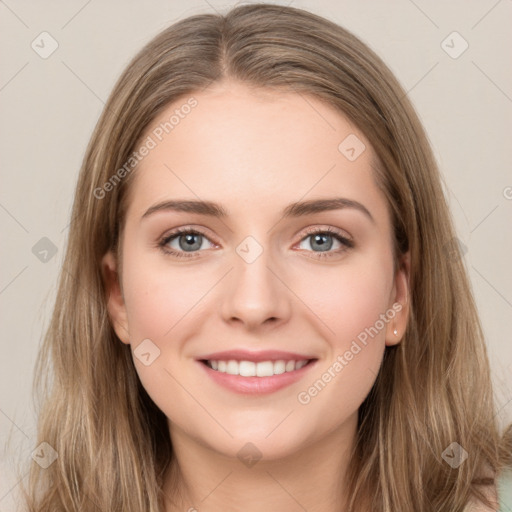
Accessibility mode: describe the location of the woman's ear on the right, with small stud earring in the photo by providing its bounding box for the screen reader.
[386,251,411,346]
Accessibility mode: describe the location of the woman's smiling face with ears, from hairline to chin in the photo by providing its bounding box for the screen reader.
[102,82,408,459]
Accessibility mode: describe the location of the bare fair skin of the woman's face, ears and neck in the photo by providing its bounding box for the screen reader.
[102,82,409,512]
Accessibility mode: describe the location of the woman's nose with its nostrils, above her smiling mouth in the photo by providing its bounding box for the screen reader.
[221,245,293,330]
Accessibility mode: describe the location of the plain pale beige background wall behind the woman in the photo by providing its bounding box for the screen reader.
[0,0,512,511]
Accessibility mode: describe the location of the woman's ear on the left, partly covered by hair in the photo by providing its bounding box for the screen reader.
[101,251,130,345]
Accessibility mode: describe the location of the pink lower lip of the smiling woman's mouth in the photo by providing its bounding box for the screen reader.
[196,360,318,395]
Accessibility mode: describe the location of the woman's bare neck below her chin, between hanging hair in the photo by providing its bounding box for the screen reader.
[164,413,357,512]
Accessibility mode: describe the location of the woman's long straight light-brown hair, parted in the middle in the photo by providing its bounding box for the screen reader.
[17,4,512,512]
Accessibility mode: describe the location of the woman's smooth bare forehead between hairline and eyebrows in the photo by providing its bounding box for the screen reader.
[128,82,386,224]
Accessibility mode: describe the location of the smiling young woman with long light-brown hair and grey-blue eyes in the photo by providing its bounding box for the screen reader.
[17,4,512,512]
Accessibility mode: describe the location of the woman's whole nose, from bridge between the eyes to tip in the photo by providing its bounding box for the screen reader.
[223,236,289,326]
